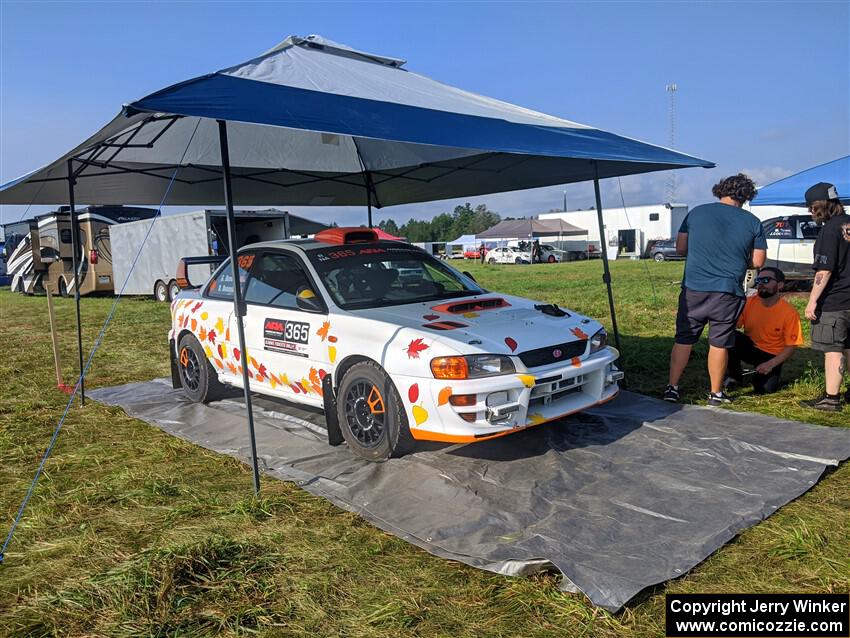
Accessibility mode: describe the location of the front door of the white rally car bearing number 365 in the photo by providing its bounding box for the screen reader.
[242,250,330,405]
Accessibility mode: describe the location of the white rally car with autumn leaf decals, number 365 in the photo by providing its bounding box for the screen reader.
[169,228,622,460]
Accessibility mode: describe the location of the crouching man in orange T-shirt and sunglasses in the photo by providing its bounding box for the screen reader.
[726,267,803,394]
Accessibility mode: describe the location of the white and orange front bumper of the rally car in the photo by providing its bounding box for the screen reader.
[394,347,623,443]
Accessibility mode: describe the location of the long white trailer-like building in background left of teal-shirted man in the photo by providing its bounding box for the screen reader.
[538,204,688,257]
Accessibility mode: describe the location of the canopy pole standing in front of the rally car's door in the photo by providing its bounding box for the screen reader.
[217,120,260,494]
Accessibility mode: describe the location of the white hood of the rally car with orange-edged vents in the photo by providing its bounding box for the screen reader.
[350,293,602,355]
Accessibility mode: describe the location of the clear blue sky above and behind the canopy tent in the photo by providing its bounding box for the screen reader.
[0,0,850,230]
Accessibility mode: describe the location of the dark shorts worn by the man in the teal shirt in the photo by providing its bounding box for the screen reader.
[676,286,747,348]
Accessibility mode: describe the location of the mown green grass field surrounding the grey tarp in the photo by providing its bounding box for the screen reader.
[0,261,850,637]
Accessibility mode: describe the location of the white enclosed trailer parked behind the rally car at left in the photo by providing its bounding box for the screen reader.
[112,209,327,301]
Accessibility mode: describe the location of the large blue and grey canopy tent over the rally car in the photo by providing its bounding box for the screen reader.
[0,36,714,491]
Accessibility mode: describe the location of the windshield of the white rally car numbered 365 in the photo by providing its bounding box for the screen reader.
[308,244,484,310]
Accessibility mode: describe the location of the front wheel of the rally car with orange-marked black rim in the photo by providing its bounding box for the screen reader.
[337,361,414,461]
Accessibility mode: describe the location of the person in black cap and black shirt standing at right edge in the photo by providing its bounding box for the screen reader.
[801,182,850,412]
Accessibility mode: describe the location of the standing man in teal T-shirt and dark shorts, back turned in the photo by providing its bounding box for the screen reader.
[664,173,767,406]
